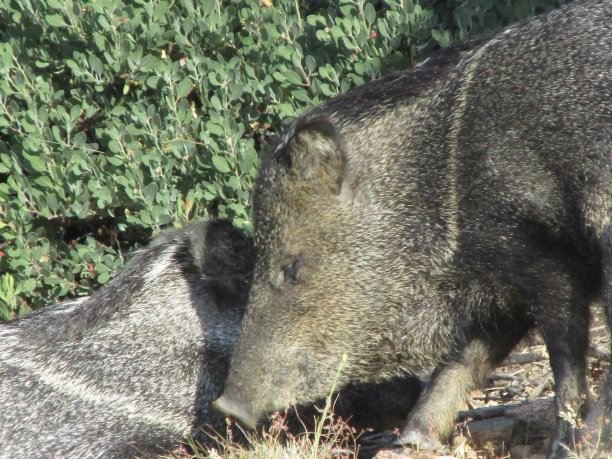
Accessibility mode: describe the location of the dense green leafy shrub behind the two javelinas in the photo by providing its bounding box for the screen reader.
[0,0,557,318]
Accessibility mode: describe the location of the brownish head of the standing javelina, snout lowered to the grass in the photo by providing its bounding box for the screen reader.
[216,118,406,426]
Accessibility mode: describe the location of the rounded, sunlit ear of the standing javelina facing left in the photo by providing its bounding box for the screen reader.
[290,118,352,201]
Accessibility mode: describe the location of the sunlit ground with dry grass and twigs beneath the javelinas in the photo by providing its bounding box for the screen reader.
[184,309,612,459]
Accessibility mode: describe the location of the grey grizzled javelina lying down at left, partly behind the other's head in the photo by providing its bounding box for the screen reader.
[0,221,253,458]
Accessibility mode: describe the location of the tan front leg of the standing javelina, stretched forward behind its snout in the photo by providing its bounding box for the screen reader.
[397,333,523,450]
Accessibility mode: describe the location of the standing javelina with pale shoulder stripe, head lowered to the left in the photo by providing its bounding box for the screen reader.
[216,1,612,454]
